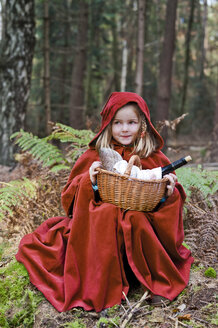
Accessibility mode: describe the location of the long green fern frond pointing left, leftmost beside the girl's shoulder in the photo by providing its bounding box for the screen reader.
[11,130,69,169]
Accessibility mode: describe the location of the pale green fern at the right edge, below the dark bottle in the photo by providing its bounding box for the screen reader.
[176,167,218,198]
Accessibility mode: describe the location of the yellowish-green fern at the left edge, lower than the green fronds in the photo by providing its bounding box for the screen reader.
[0,178,37,219]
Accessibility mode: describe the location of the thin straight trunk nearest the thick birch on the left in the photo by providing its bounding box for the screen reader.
[44,0,51,134]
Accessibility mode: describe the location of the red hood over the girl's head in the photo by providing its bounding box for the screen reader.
[89,92,164,150]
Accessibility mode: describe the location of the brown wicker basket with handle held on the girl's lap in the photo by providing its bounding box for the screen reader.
[97,155,168,212]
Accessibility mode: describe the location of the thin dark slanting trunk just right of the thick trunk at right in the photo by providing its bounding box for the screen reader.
[179,0,196,116]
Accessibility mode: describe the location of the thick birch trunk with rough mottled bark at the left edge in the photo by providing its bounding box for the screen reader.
[0,0,35,165]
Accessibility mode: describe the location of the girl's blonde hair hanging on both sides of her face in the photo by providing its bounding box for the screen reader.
[95,102,157,158]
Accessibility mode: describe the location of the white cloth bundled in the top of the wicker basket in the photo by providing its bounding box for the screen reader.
[113,160,162,180]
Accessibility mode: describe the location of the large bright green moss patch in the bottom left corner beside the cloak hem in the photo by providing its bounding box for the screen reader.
[0,259,43,328]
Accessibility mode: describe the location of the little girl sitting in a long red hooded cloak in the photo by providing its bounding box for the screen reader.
[16,92,193,312]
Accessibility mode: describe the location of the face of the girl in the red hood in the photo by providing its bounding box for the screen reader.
[112,104,141,145]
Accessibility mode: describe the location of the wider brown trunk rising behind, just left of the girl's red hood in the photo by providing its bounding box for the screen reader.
[70,0,88,129]
